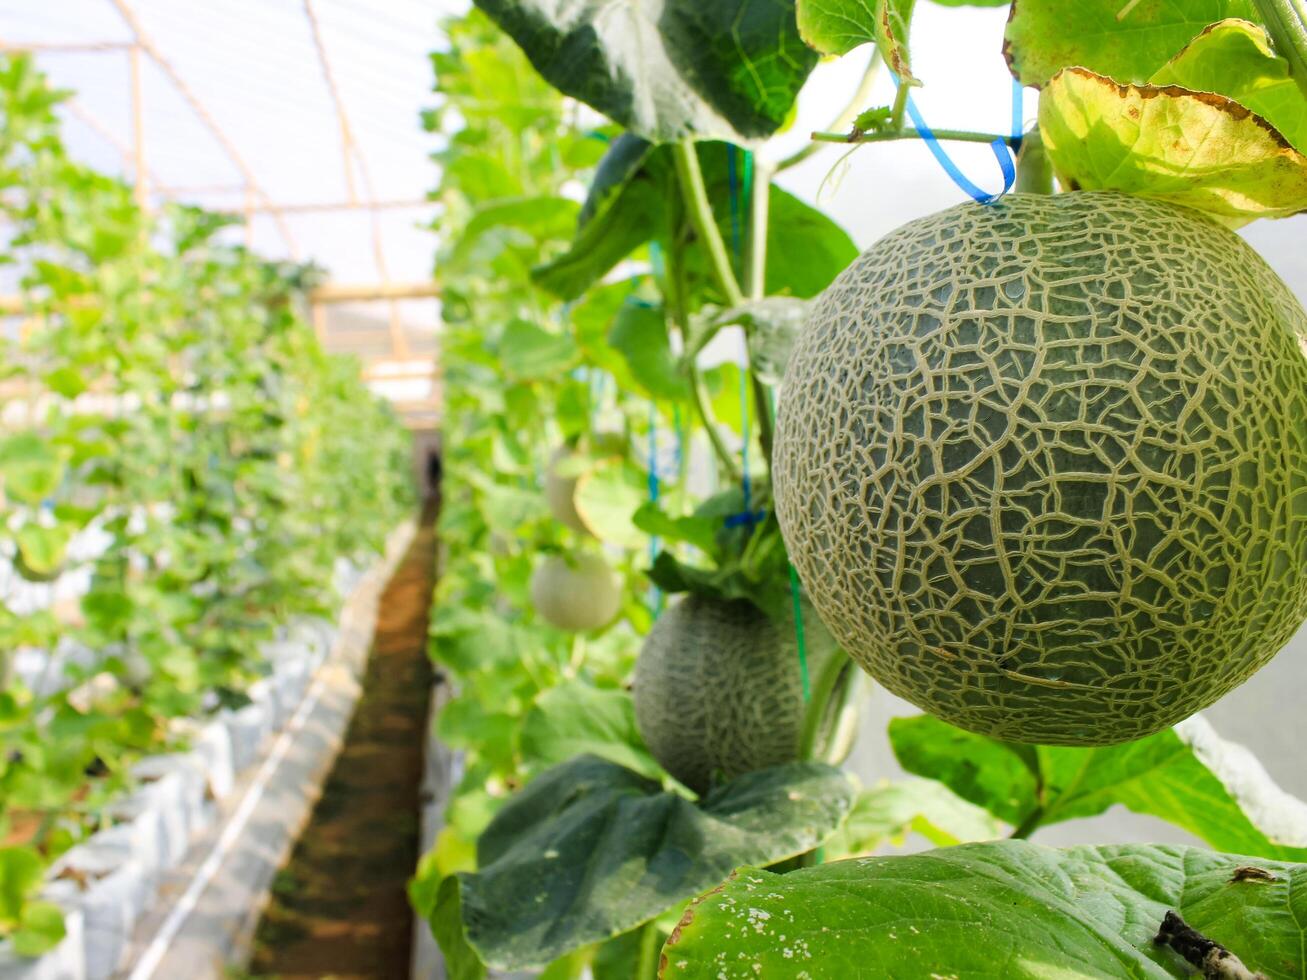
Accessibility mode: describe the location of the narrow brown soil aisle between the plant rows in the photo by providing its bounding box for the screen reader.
[250,503,437,980]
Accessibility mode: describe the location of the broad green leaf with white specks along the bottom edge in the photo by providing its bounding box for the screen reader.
[663,840,1307,980]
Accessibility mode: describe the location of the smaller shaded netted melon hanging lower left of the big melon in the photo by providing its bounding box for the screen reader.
[633,595,848,793]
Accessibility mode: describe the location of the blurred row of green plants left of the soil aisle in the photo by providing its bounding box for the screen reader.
[0,56,412,953]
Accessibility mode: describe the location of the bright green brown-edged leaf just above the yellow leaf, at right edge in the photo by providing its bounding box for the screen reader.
[1149,20,1307,153]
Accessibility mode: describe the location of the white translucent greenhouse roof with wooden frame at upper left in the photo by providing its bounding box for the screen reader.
[0,0,465,428]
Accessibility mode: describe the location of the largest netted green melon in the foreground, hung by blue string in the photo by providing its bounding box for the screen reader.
[774,192,1307,745]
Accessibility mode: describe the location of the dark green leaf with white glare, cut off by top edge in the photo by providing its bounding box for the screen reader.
[477,0,817,142]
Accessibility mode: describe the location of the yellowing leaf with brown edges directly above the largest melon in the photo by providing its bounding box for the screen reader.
[1039,68,1307,226]
